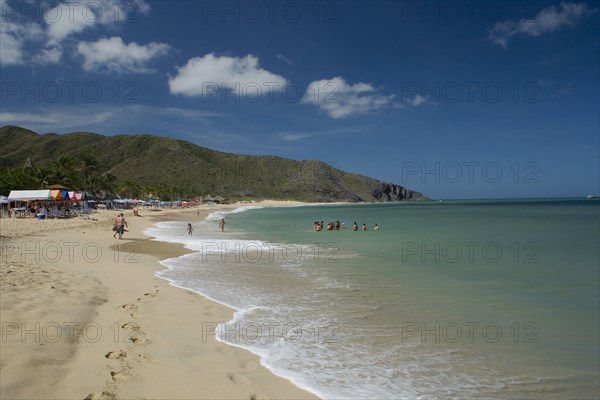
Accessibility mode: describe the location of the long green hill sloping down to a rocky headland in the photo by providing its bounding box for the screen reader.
[0,126,427,202]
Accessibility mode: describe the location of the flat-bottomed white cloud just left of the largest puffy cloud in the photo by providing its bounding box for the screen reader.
[77,36,169,73]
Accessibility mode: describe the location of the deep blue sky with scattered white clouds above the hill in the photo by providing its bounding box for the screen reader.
[0,0,600,198]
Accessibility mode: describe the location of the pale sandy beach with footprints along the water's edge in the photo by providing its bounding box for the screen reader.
[0,202,315,399]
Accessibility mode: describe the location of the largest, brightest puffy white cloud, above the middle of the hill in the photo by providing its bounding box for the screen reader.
[169,53,287,96]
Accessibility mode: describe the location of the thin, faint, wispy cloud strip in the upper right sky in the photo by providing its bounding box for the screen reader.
[488,2,598,48]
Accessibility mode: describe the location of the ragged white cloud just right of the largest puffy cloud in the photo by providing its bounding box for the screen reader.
[302,77,394,119]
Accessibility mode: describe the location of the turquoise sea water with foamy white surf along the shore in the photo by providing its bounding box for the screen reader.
[148,199,600,399]
